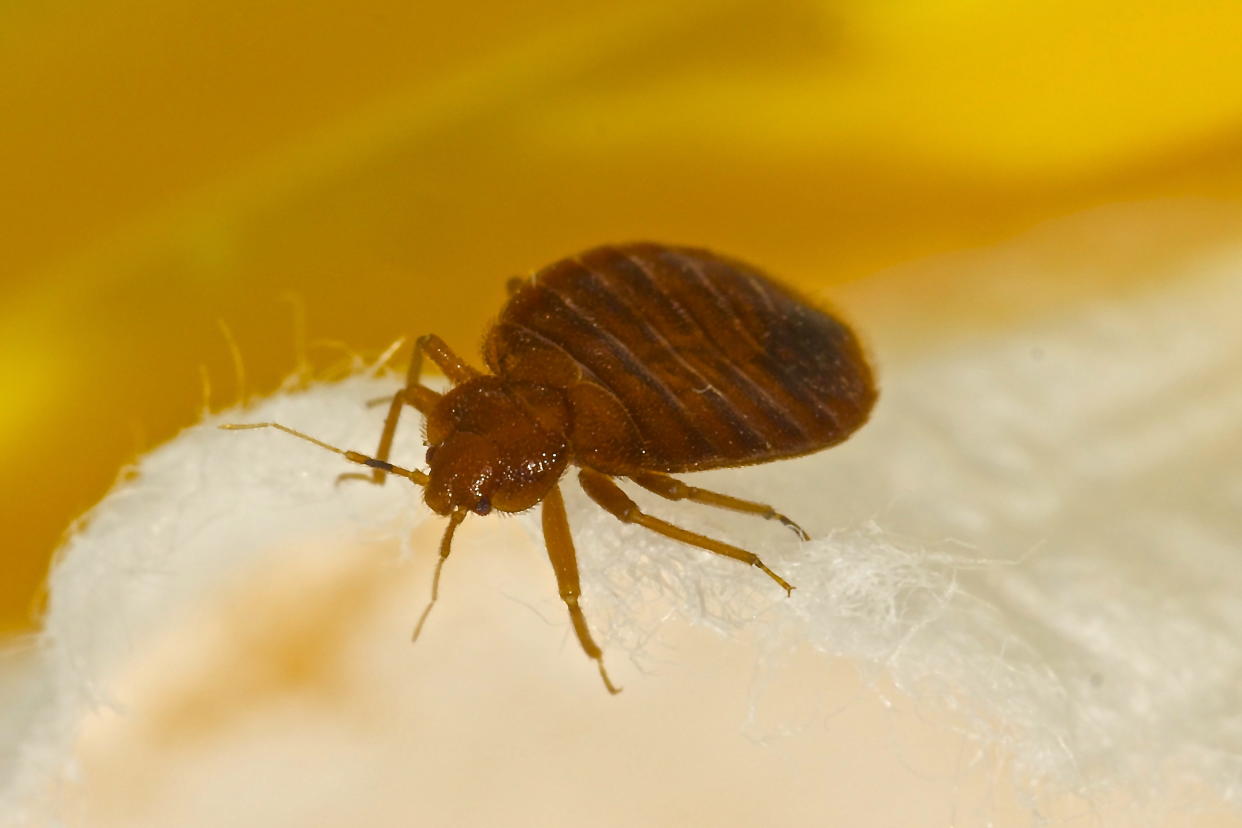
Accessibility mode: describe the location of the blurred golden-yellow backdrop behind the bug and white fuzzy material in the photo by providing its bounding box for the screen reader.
[0,0,1242,631]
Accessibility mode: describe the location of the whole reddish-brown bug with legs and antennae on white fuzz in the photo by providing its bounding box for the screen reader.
[225,243,877,693]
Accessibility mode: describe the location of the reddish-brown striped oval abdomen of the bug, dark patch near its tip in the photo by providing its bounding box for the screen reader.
[487,243,876,472]
